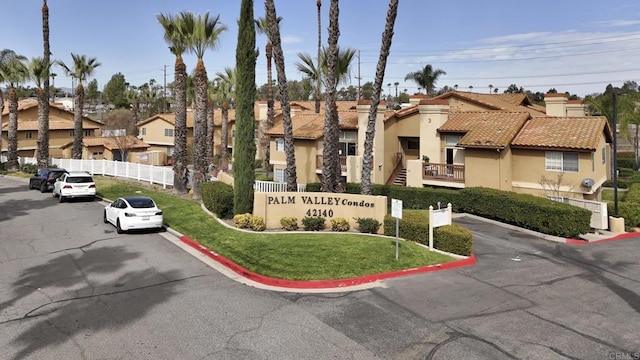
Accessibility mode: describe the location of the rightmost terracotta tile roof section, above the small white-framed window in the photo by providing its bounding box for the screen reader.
[512,116,611,151]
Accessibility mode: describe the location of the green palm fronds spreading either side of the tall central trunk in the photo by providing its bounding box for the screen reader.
[295,47,356,93]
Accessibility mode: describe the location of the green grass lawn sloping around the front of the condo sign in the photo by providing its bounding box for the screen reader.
[94,176,454,280]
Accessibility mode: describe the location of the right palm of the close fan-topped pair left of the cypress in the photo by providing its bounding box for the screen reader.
[180,12,227,199]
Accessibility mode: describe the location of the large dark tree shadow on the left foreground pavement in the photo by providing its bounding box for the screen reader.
[0,246,185,359]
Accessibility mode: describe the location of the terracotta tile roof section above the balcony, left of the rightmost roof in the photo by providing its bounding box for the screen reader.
[438,111,529,148]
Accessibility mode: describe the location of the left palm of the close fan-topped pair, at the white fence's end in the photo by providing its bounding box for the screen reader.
[156,14,189,194]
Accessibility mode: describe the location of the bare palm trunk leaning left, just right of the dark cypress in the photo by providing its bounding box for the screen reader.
[264,0,298,191]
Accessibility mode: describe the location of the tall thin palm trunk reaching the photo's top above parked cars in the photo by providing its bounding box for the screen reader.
[38,0,51,168]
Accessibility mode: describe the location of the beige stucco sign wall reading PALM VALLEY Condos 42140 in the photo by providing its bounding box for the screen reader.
[253,192,387,233]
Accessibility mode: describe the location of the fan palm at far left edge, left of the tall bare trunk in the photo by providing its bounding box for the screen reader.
[0,51,29,171]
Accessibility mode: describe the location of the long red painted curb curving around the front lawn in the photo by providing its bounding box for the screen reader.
[180,236,476,289]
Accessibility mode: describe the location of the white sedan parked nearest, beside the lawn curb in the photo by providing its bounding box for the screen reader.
[103,196,163,234]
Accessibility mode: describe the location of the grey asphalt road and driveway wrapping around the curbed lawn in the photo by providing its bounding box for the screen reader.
[0,177,640,360]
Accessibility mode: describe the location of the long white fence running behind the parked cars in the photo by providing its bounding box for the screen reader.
[51,159,173,189]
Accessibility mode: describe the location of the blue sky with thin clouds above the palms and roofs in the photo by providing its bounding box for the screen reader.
[5,0,640,96]
